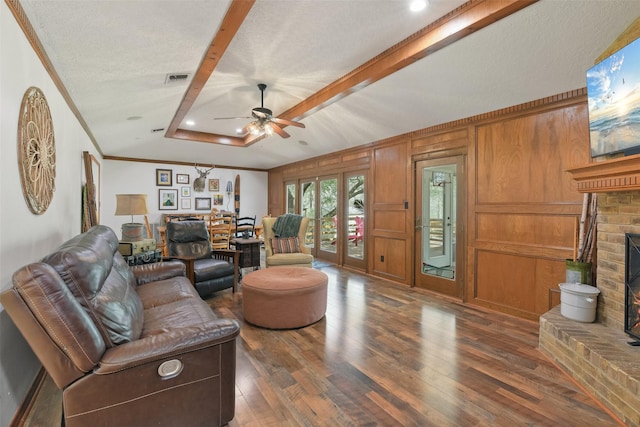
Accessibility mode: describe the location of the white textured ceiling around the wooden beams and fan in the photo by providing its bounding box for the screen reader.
[16,0,640,168]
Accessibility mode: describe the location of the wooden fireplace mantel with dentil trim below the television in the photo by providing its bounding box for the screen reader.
[567,154,640,193]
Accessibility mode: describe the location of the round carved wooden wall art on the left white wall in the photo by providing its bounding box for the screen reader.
[18,87,56,215]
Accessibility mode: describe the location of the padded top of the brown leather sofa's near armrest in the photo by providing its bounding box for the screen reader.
[94,319,240,375]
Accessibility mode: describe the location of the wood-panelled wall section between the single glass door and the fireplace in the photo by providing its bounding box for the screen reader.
[466,92,590,319]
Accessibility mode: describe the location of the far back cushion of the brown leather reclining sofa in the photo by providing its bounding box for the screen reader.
[42,226,144,347]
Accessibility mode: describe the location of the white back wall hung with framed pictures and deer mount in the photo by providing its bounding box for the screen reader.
[100,160,268,238]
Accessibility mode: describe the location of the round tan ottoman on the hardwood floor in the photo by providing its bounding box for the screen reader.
[242,267,328,329]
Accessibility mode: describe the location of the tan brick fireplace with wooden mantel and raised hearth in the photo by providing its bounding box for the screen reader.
[539,156,640,426]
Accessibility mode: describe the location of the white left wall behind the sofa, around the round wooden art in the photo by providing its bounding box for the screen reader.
[0,2,100,427]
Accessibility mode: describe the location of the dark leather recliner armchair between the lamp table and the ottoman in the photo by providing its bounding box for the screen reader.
[166,221,240,297]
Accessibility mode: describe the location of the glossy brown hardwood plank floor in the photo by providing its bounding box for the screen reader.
[25,267,621,427]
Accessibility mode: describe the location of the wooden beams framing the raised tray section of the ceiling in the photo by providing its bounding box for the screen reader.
[165,0,538,147]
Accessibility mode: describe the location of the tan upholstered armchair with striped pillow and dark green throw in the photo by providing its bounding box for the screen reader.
[262,214,313,268]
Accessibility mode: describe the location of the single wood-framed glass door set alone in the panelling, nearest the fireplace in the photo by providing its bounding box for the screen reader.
[415,156,464,298]
